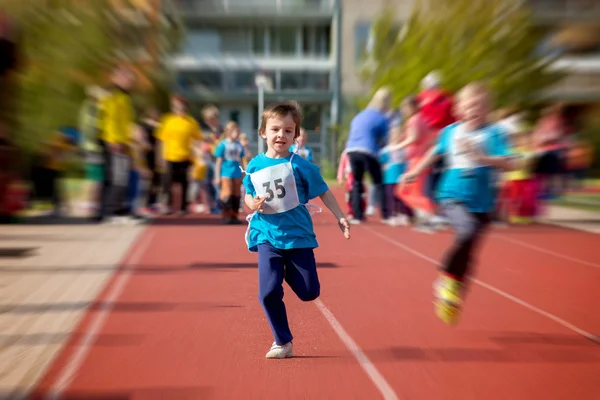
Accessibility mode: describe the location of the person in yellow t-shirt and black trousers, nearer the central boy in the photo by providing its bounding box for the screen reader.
[155,96,202,214]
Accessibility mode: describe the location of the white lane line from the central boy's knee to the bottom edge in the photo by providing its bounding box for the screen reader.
[315,299,398,400]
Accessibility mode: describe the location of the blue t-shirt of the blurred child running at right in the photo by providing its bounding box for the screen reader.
[436,123,509,212]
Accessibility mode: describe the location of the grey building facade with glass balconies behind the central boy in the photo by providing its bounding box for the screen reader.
[172,0,340,164]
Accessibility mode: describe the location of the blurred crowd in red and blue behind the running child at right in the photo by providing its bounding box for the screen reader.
[337,72,594,232]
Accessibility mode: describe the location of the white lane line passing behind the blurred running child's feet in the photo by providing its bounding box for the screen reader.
[364,226,600,344]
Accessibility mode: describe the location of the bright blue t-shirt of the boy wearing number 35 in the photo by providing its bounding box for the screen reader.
[244,153,329,251]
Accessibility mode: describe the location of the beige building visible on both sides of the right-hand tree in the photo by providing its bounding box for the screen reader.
[341,0,600,108]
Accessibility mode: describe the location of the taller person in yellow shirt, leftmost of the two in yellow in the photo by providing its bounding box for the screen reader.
[95,67,135,222]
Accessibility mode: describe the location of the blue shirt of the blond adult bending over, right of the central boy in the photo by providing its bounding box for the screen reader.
[346,108,390,156]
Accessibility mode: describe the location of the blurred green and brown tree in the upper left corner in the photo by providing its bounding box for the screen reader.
[0,0,182,158]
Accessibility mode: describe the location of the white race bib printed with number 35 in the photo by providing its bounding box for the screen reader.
[250,162,300,214]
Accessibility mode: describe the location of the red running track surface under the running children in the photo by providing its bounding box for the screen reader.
[33,191,600,400]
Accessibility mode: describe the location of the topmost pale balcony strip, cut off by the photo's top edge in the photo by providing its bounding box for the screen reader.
[175,0,336,16]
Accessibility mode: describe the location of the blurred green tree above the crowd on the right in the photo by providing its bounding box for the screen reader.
[359,0,562,106]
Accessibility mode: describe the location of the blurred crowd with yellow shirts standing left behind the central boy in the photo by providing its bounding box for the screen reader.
[15,67,312,224]
